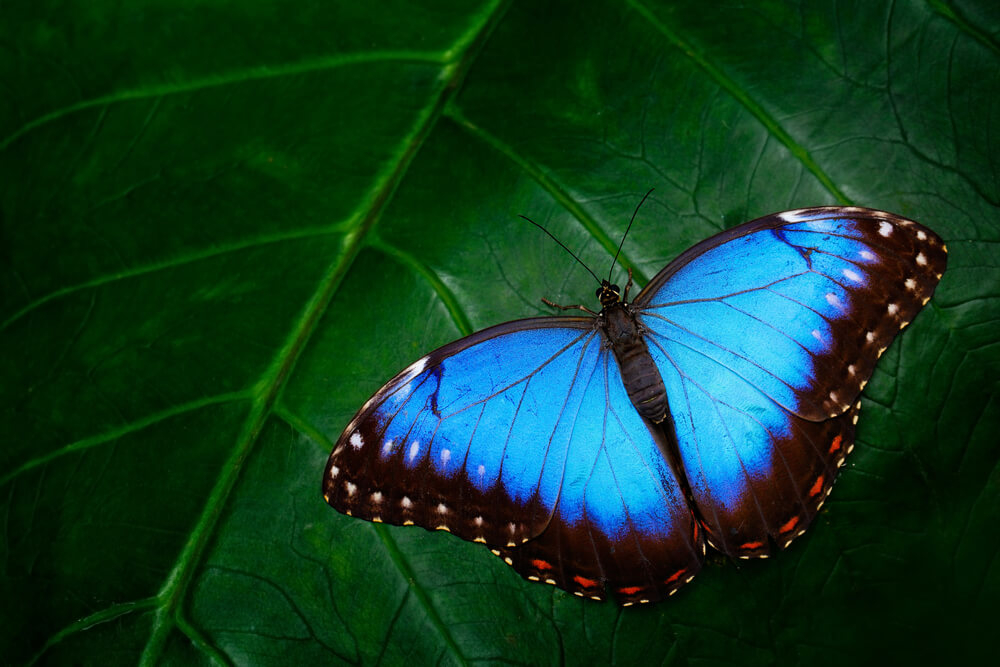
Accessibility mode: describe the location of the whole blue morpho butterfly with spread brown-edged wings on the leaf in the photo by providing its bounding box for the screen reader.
[323,193,947,605]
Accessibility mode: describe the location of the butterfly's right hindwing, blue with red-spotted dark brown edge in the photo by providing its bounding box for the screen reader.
[650,335,857,558]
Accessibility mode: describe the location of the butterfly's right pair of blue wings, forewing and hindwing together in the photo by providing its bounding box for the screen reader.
[633,207,947,558]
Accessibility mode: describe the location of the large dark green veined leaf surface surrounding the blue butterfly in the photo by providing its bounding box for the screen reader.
[0,0,1000,665]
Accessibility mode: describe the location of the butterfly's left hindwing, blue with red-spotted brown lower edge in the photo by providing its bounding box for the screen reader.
[503,348,705,605]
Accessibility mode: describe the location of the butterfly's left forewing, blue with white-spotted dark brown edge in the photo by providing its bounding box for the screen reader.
[323,318,593,546]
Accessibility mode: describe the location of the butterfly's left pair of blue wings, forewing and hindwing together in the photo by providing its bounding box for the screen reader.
[323,317,704,604]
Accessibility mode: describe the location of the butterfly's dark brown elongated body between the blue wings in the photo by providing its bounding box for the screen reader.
[601,303,667,423]
